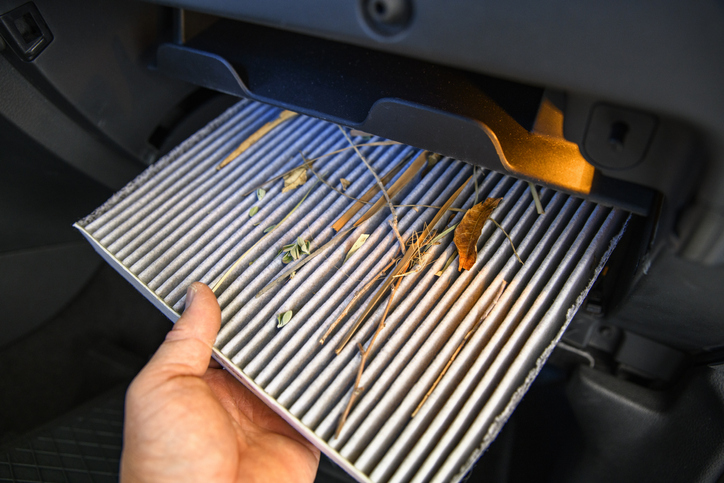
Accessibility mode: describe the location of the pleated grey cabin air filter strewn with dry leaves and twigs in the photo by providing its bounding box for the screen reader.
[76,101,627,482]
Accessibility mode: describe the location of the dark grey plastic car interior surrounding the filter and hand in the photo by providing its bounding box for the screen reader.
[0,0,724,483]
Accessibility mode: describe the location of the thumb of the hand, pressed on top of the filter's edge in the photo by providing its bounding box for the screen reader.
[143,282,221,377]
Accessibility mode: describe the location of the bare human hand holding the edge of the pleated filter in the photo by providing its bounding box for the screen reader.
[120,282,319,483]
